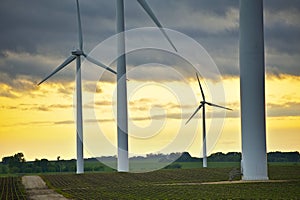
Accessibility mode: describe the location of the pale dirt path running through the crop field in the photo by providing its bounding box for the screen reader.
[22,176,66,200]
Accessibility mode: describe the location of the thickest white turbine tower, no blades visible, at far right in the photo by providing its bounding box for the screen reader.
[239,0,269,180]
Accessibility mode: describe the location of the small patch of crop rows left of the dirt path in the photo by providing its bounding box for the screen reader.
[0,176,27,200]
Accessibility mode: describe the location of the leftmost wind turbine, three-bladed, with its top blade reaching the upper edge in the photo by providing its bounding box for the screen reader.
[38,0,117,174]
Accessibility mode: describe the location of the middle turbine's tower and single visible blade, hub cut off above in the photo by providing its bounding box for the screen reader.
[116,0,177,172]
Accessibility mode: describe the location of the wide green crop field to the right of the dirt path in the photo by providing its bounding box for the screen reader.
[42,165,300,199]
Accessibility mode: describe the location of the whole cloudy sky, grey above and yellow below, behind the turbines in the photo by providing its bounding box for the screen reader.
[0,0,300,160]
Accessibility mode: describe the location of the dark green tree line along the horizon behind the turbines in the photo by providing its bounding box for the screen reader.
[0,151,300,174]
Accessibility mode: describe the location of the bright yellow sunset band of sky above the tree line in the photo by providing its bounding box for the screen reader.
[0,75,300,160]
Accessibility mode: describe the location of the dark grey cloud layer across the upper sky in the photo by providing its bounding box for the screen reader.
[0,0,300,92]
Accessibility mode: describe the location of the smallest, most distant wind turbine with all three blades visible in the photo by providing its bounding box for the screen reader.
[185,73,232,167]
